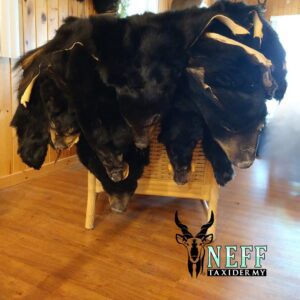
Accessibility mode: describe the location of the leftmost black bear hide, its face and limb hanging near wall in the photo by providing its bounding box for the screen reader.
[11,47,79,169]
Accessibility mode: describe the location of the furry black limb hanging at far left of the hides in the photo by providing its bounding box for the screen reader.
[10,83,50,169]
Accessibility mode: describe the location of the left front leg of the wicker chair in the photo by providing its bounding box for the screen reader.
[85,172,96,229]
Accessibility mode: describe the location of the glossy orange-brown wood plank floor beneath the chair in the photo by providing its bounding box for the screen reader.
[0,160,300,300]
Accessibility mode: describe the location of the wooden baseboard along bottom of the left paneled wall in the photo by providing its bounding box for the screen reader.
[0,155,78,189]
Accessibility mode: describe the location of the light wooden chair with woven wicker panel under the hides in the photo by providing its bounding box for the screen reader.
[85,138,219,238]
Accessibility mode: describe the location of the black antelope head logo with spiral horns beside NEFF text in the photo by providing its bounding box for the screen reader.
[175,211,214,277]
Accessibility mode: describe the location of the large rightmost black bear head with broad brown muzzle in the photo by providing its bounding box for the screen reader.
[190,29,267,167]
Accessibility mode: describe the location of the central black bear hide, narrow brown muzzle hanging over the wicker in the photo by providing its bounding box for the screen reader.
[91,9,212,148]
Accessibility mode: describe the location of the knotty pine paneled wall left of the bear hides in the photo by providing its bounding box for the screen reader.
[0,0,93,187]
